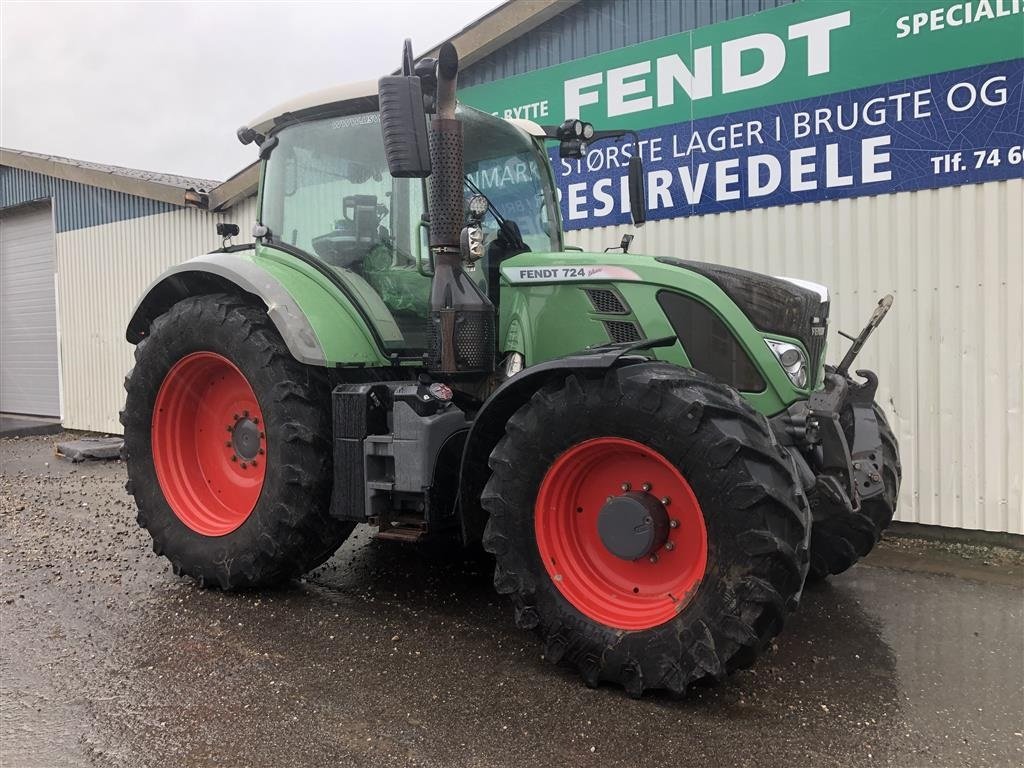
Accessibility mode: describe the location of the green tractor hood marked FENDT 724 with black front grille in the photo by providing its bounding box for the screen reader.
[499,251,828,413]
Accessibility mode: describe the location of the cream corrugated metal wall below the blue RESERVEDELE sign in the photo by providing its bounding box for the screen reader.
[566,179,1024,534]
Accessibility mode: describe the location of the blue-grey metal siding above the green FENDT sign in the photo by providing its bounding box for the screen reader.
[459,0,793,87]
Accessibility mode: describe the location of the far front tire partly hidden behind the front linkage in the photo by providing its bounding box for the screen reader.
[809,402,902,581]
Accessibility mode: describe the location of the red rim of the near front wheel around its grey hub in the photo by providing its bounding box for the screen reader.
[534,437,708,630]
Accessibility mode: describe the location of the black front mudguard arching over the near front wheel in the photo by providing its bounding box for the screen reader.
[459,336,676,544]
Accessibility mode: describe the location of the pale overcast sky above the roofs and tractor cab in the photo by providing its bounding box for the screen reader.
[0,0,501,180]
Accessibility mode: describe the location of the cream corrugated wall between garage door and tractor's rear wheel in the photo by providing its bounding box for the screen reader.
[56,196,256,434]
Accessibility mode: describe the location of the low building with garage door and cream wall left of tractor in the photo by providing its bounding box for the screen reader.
[0,150,255,432]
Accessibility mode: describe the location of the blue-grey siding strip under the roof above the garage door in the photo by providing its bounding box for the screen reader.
[0,166,178,232]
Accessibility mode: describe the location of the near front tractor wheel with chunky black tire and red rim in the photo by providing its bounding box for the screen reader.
[481,362,810,696]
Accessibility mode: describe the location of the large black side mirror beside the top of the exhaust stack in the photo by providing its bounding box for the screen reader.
[377,40,430,178]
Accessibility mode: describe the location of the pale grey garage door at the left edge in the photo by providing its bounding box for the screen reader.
[0,204,60,416]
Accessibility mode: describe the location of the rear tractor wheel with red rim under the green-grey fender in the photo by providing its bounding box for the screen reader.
[121,294,354,589]
